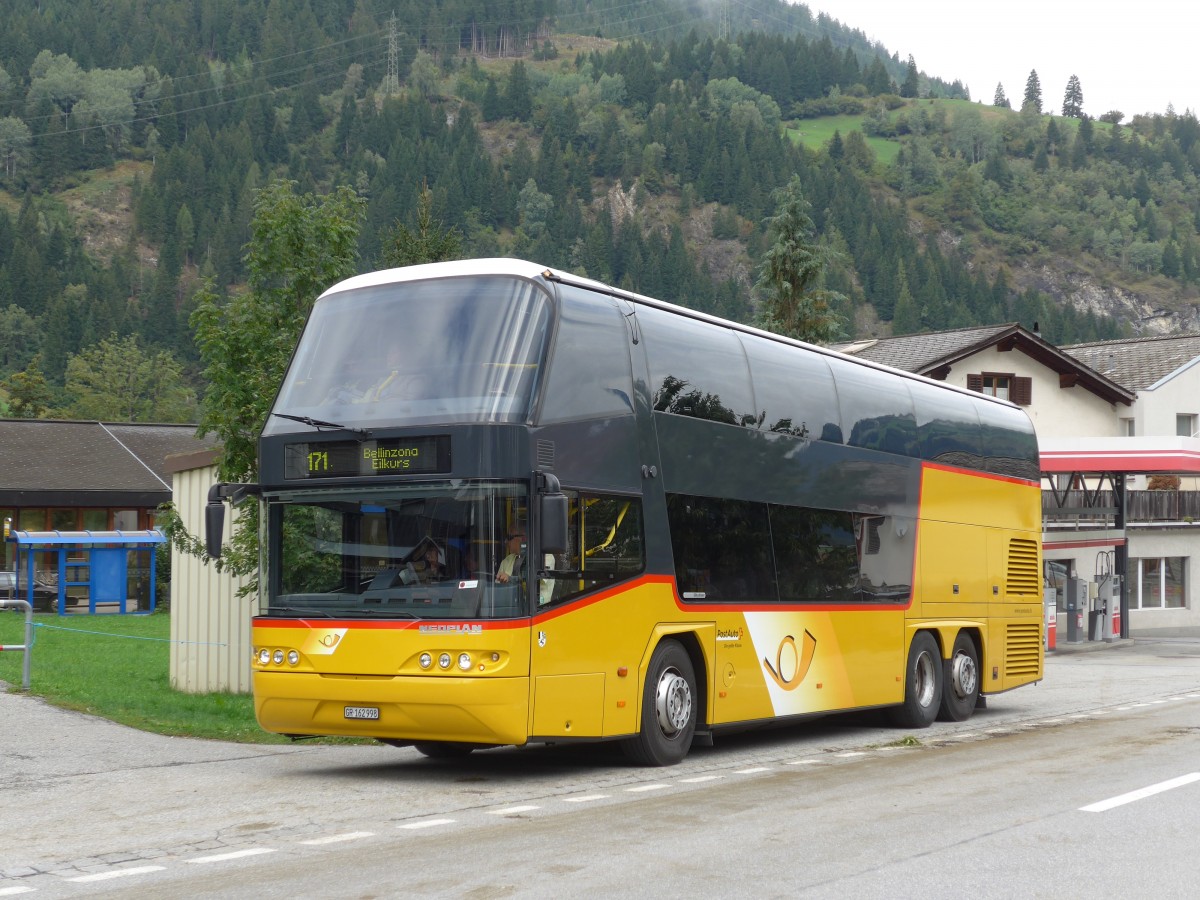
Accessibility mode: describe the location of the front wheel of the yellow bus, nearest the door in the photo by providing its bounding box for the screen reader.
[622,641,700,766]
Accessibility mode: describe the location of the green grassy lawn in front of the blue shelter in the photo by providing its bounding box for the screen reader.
[0,610,304,744]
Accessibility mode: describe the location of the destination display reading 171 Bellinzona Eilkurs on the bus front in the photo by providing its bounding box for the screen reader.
[283,434,450,479]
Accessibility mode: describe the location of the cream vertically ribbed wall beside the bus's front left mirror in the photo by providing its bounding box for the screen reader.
[170,466,256,694]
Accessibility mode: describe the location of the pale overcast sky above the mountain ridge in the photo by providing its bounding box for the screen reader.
[805,0,1200,121]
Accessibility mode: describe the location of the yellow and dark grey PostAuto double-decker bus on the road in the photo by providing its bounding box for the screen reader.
[210,259,1043,766]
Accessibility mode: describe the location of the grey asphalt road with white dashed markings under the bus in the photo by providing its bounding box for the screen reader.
[0,640,1200,898]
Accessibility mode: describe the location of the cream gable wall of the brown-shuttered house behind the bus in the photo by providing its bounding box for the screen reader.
[946,347,1118,438]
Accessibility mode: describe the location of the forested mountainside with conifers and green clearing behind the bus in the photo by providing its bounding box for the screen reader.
[0,0,1200,415]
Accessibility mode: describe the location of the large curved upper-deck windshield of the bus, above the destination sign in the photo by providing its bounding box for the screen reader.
[263,277,550,436]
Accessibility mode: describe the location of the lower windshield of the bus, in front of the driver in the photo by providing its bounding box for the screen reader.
[262,481,536,620]
